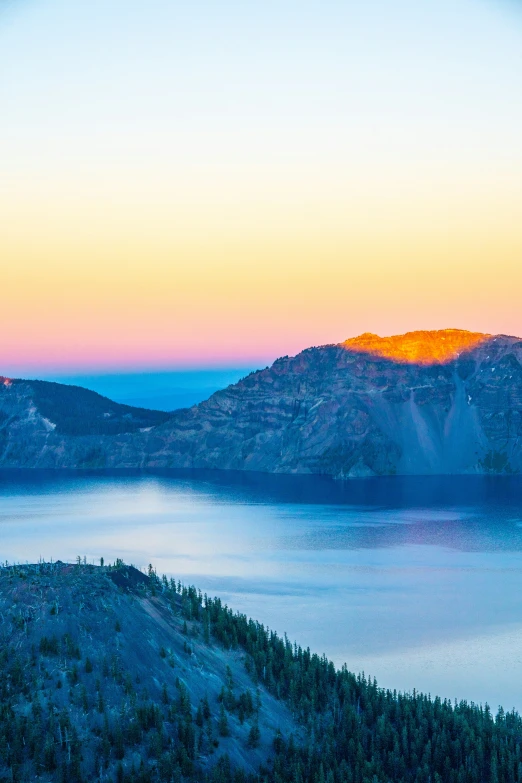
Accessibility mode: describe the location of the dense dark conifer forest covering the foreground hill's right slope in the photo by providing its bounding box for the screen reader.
[153,575,522,783]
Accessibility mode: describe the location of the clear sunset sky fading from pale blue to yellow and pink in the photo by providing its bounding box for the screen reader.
[0,0,522,376]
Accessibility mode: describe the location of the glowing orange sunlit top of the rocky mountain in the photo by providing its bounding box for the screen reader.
[341,329,491,365]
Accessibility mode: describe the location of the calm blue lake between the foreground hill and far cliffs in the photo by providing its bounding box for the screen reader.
[0,472,522,710]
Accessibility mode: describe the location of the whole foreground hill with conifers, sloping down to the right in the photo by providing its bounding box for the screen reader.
[0,561,522,783]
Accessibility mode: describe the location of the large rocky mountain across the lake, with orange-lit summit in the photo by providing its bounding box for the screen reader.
[0,330,522,477]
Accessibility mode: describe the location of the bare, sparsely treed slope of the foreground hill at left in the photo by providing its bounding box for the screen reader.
[0,561,296,783]
